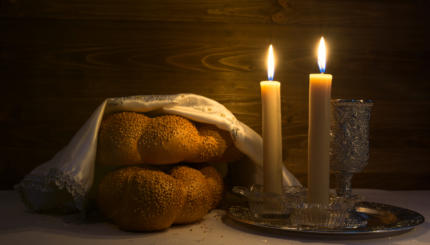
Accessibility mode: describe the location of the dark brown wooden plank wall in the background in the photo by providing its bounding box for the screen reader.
[0,0,430,189]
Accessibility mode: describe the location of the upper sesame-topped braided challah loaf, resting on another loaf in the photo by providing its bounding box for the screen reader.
[97,112,240,165]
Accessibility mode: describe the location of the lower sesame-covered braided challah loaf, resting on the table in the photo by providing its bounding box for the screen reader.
[97,166,223,231]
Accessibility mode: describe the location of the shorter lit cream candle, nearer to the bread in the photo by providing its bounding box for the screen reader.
[260,45,282,194]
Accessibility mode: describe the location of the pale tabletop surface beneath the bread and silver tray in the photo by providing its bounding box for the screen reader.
[0,189,430,245]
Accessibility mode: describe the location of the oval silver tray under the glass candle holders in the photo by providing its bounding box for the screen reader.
[227,202,424,238]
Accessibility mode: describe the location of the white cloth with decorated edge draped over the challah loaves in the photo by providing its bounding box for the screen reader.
[16,94,300,211]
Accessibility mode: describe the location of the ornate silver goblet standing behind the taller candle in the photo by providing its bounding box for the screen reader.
[330,99,373,198]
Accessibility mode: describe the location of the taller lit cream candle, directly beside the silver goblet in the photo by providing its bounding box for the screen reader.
[308,37,332,205]
